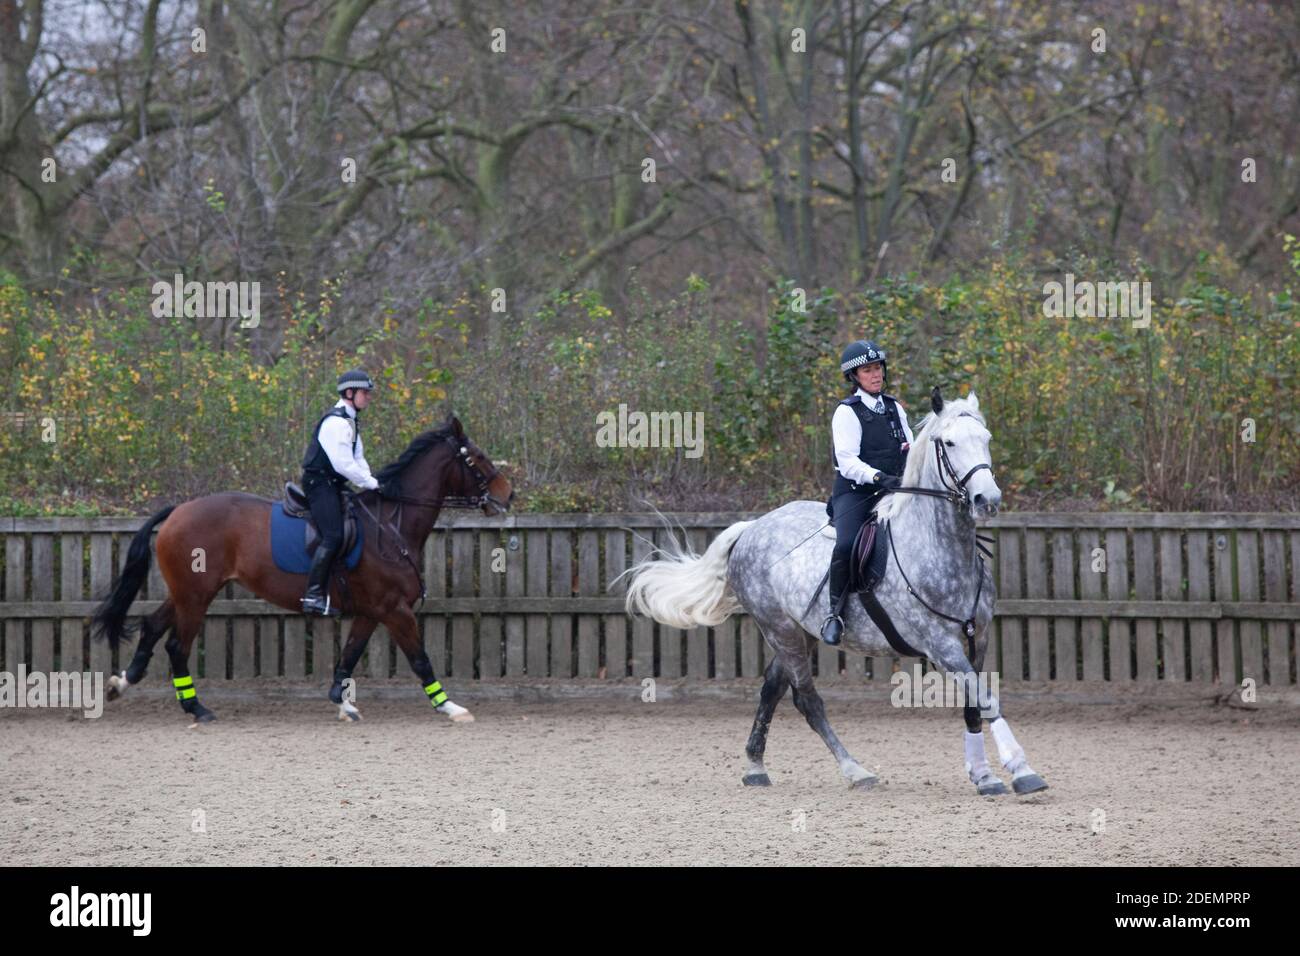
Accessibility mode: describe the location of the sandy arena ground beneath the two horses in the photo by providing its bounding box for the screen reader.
[0,678,1300,866]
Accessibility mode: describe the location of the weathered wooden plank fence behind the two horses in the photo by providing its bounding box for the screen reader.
[0,514,1300,685]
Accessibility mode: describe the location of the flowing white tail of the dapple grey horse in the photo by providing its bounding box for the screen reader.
[625,522,753,628]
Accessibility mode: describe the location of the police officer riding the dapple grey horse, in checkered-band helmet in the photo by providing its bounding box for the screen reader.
[822,341,911,644]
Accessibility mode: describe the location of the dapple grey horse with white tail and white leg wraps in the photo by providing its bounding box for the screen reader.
[627,388,1047,796]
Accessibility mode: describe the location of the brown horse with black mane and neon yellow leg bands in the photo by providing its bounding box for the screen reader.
[92,418,514,723]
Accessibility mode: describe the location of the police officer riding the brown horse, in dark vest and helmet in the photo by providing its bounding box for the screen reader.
[302,368,380,617]
